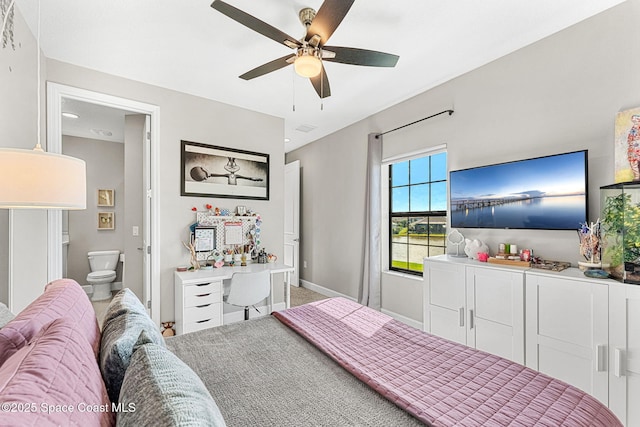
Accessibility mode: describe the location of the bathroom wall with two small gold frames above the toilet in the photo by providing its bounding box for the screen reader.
[62,136,125,285]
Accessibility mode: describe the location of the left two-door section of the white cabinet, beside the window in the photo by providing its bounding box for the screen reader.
[423,255,524,364]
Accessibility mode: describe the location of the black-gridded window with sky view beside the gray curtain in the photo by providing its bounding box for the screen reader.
[389,153,447,274]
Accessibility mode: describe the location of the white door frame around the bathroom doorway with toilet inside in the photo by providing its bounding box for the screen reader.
[47,82,160,325]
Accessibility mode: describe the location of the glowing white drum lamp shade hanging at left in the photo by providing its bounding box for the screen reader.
[0,148,87,209]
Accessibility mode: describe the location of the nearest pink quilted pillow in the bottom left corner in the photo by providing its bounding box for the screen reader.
[0,317,115,426]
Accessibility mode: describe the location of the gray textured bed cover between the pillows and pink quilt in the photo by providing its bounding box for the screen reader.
[167,316,422,427]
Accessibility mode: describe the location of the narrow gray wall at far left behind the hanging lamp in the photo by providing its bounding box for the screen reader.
[0,8,47,311]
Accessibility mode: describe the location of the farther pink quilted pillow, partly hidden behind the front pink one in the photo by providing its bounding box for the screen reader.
[0,279,100,366]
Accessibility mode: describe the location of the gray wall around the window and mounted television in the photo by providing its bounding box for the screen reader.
[286,0,640,322]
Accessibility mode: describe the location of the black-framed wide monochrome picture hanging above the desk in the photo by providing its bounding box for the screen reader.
[180,140,269,200]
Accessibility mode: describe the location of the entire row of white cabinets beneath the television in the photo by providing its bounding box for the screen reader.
[423,255,640,427]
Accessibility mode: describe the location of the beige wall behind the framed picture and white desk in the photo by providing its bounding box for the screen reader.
[47,60,284,321]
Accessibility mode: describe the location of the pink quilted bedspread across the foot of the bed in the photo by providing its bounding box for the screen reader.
[274,298,622,427]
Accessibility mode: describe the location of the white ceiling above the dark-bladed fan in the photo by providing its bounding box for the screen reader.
[16,0,623,152]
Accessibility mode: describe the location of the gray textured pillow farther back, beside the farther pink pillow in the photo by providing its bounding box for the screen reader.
[100,288,165,402]
